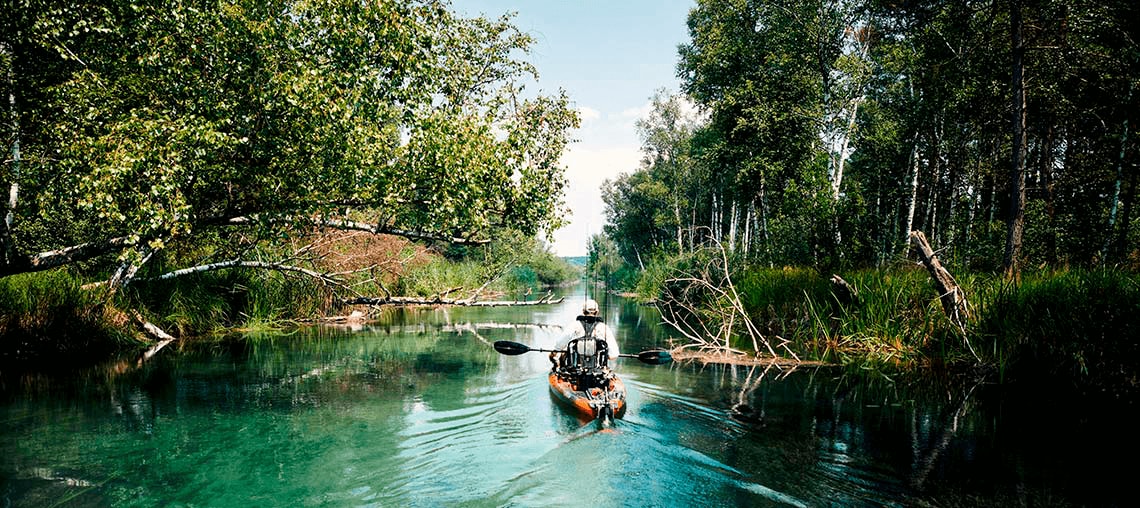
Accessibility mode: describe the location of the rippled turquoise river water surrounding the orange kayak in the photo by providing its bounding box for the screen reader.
[0,294,1138,507]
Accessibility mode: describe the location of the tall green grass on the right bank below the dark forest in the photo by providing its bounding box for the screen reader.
[642,268,1140,391]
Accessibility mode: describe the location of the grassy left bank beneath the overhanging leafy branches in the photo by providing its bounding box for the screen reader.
[0,235,578,366]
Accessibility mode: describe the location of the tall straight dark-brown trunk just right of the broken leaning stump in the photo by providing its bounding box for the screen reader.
[1004,0,1028,278]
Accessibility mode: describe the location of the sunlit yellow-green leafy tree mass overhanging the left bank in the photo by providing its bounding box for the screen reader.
[0,0,578,288]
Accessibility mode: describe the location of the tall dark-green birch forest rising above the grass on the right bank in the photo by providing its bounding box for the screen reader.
[605,0,1140,272]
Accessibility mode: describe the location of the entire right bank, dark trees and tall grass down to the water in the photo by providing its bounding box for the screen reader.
[592,0,1140,386]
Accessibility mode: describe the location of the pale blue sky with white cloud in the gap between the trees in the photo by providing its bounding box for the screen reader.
[453,0,695,256]
